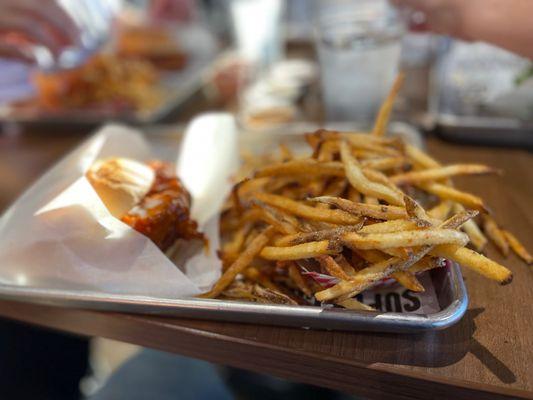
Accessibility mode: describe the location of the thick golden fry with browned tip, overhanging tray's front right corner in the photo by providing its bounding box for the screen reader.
[430,245,513,285]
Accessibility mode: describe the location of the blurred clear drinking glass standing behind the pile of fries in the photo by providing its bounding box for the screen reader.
[316,0,405,127]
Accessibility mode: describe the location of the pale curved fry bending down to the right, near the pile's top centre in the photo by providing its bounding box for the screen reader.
[341,142,403,206]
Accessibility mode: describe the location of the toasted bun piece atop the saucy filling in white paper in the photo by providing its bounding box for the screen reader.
[87,158,155,218]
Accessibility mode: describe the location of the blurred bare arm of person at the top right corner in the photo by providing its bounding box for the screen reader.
[391,0,533,59]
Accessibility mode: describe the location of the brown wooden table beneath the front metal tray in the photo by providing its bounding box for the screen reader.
[0,126,533,399]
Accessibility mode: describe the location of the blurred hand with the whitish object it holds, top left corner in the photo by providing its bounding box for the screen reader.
[0,0,120,68]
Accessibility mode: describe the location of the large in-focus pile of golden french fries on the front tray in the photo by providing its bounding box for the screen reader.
[202,76,532,310]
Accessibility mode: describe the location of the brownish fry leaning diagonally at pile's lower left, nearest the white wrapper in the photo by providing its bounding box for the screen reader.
[200,227,274,298]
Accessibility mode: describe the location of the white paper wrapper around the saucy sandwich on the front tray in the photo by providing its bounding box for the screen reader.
[0,114,238,298]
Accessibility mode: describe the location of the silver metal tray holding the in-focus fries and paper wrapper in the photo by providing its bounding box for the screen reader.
[0,127,468,333]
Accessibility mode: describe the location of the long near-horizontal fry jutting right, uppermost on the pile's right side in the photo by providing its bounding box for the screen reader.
[391,164,499,185]
